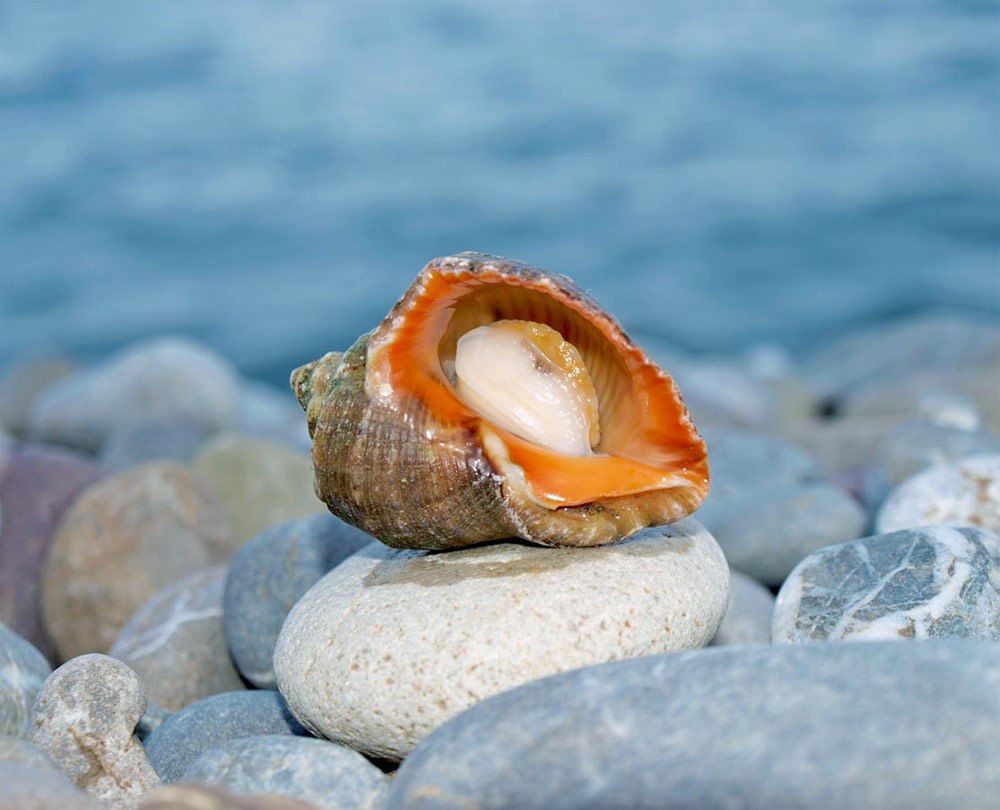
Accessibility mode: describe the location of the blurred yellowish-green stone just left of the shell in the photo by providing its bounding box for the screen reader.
[194,433,326,540]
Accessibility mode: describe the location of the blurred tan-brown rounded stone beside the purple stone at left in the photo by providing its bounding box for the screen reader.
[42,462,238,658]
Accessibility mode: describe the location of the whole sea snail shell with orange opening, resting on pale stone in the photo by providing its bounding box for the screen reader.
[291,253,708,549]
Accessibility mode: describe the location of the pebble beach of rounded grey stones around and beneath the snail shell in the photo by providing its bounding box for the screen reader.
[0,306,1000,810]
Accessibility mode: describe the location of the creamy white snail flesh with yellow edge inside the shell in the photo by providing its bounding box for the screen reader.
[455,320,600,456]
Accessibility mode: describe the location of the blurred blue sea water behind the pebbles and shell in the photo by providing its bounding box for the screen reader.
[0,0,1000,383]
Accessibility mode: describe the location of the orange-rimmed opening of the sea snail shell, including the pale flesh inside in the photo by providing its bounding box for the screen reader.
[369,269,708,508]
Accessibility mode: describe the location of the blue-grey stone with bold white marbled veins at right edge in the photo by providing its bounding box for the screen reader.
[772,526,1000,644]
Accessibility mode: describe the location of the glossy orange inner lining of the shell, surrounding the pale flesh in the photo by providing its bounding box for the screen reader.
[370,269,708,508]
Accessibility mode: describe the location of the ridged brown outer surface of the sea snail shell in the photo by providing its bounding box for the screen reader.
[291,253,708,549]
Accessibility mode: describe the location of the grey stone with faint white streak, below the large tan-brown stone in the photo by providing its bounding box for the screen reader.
[109,565,243,712]
